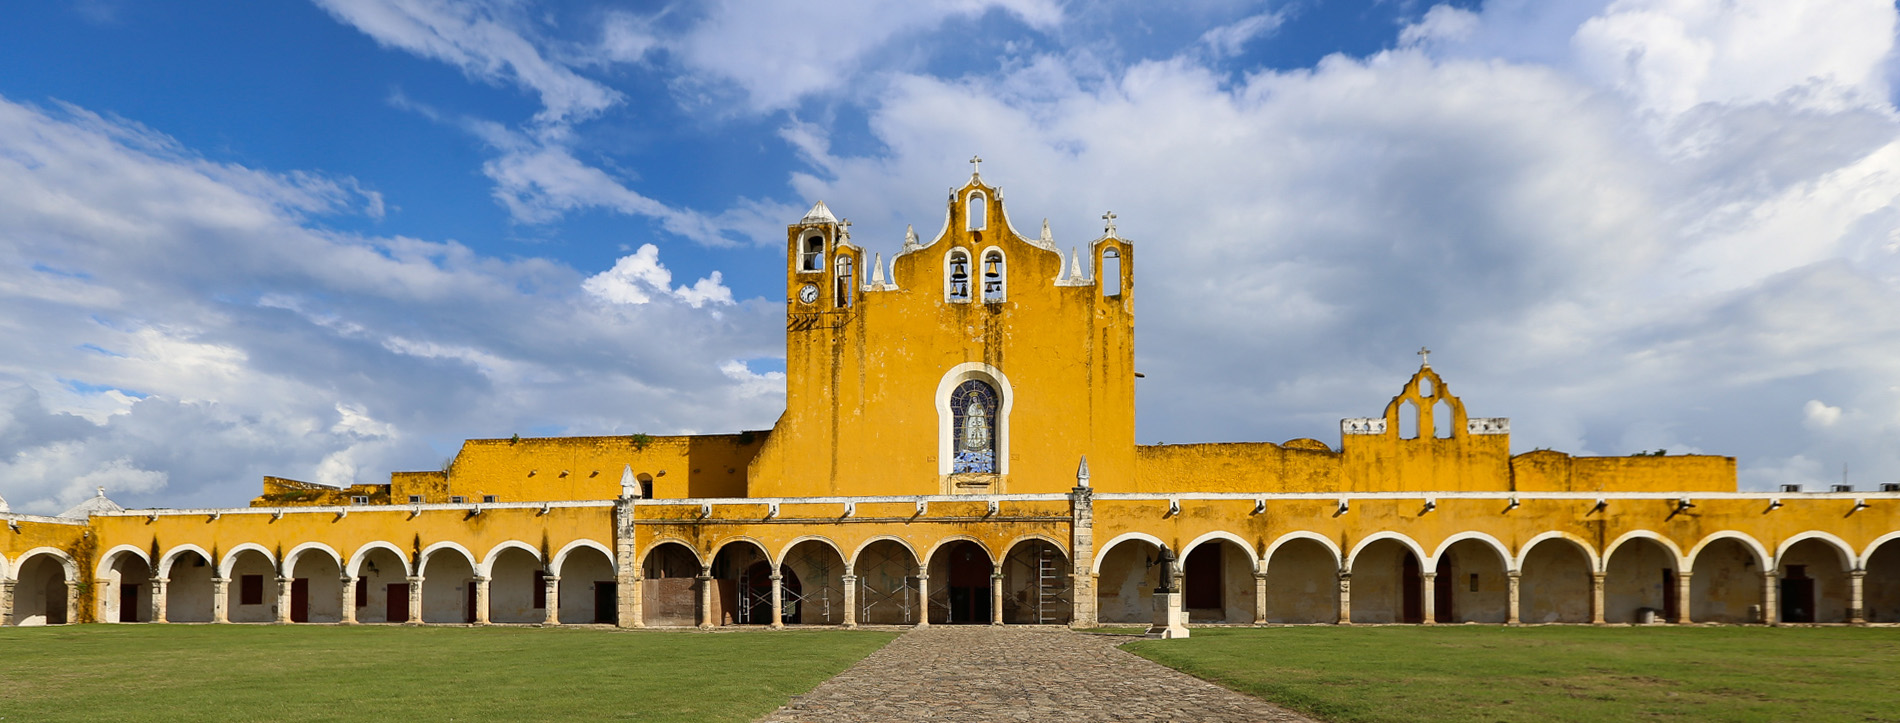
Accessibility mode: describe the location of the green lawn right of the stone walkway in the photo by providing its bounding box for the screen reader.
[1127,626,1900,721]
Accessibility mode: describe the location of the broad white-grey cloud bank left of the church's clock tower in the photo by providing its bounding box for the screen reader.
[0,99,783,512]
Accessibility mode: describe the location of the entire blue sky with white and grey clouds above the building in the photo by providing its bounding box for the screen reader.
[0,0,1900,512]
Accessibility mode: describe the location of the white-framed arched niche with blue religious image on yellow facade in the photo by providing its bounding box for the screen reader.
[937,362,1015,474]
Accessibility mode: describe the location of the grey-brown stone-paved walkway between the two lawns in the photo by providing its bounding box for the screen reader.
[760,626,1311,723]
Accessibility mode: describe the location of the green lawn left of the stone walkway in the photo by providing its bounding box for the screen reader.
[0,624,893,723]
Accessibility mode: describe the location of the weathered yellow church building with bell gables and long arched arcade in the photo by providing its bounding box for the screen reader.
[0,175,1900,626]
